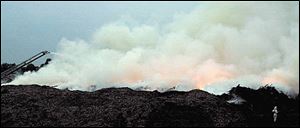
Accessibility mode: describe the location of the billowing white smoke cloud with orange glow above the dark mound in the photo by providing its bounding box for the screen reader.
[10,2,299,93]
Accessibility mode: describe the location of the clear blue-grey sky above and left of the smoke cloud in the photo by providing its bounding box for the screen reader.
[1,1,198,63]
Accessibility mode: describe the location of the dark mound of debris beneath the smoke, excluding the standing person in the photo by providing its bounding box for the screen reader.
[1,85,299,127]
